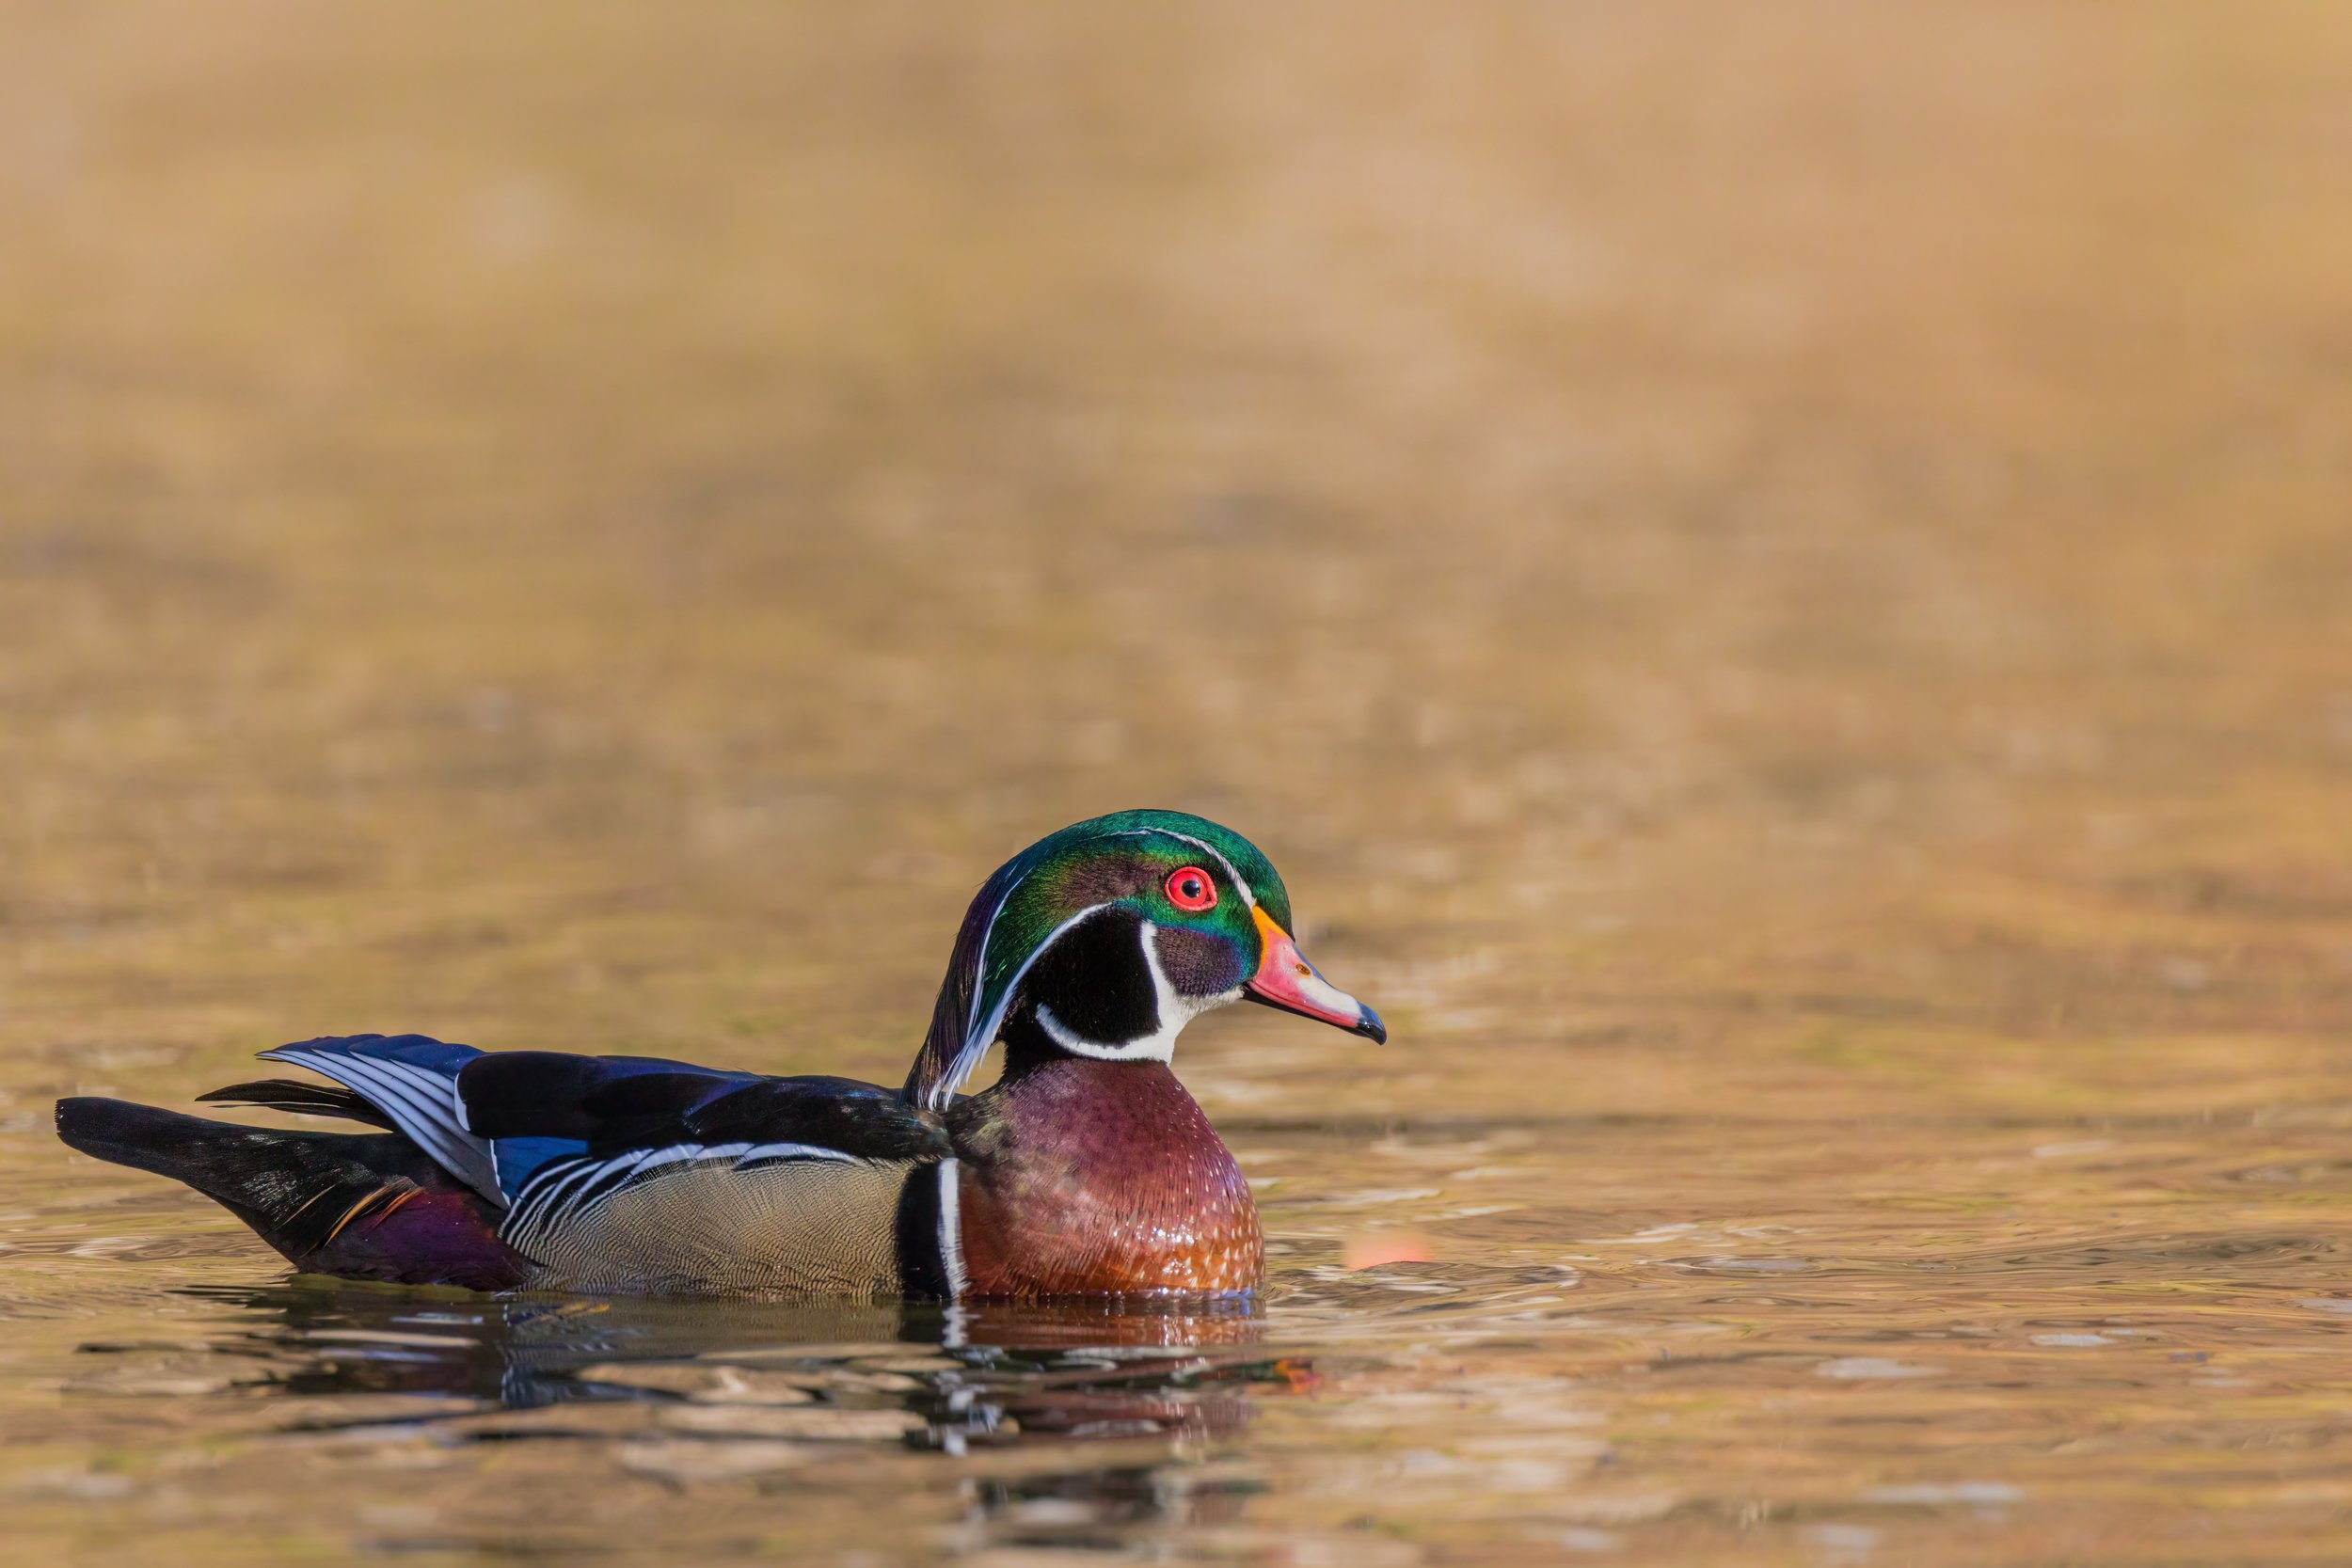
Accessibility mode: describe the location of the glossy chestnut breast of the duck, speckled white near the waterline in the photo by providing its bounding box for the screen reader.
[948,1058,1265,1295]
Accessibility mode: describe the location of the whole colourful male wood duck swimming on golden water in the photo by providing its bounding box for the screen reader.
[56,811,1388,1300]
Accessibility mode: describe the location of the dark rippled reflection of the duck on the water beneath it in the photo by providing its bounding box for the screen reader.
[174,1279,1312,1453]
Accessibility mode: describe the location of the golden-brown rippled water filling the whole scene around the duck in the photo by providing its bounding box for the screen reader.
[0,0,2352,1568]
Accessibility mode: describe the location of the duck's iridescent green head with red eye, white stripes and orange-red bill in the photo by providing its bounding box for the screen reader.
[906,811,1388,1110]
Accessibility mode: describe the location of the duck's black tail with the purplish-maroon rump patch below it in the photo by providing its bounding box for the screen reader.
[56,1098,508,1284]
